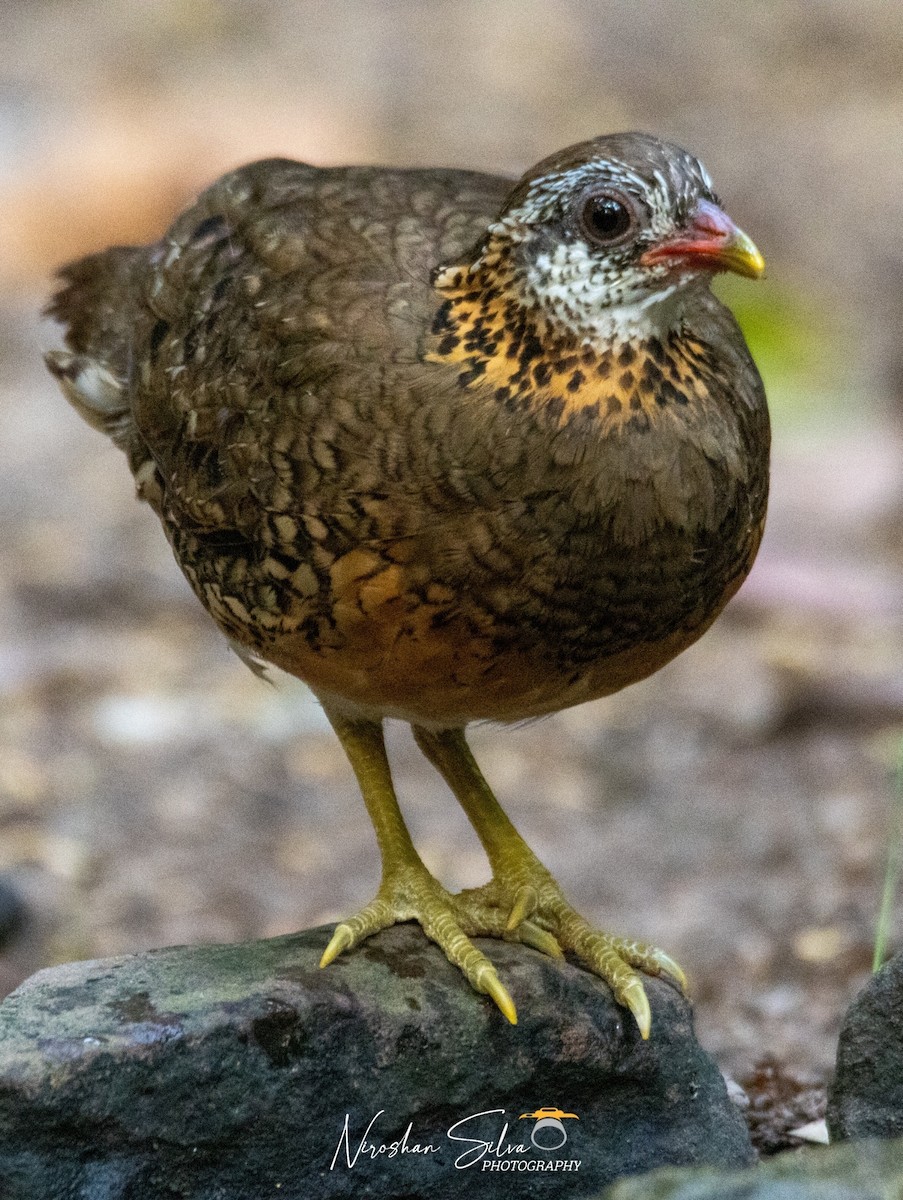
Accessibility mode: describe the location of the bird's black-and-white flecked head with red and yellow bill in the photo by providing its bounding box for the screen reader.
[441,133,765,344]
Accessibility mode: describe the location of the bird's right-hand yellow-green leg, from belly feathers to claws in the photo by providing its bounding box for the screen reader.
[413,726,687,1038]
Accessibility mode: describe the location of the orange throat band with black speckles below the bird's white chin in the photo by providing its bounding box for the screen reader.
[425,259,729,433]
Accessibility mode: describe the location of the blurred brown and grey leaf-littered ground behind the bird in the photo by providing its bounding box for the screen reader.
[0,0,903,1076]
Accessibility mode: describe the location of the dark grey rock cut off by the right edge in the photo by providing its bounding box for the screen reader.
[827,954,903,1141]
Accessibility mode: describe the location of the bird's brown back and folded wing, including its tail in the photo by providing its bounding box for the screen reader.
[48,160,510,538]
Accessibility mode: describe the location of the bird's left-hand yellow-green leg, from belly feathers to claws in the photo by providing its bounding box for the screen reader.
[319,706,518,1025]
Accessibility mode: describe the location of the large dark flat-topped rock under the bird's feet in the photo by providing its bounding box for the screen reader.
[0,925,753,1200]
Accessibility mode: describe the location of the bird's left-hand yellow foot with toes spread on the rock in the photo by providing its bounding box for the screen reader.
[319,863,525,1025]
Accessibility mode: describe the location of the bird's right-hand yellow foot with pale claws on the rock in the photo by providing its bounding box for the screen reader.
[454,852,687,1039]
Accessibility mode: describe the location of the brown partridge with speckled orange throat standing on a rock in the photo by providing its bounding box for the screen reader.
[46,133,770,1038]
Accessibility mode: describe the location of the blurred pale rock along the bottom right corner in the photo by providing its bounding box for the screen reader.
[598,1139,903,1200]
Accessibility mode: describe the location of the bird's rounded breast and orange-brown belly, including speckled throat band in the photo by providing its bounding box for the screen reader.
[158,267,766,724]
